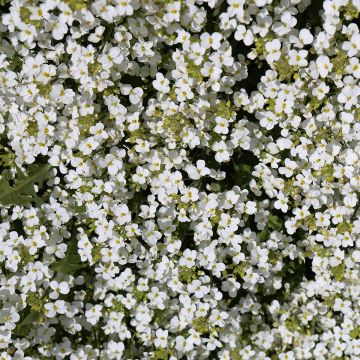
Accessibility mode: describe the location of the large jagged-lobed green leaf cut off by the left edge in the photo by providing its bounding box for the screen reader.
[0,164,51,205]
